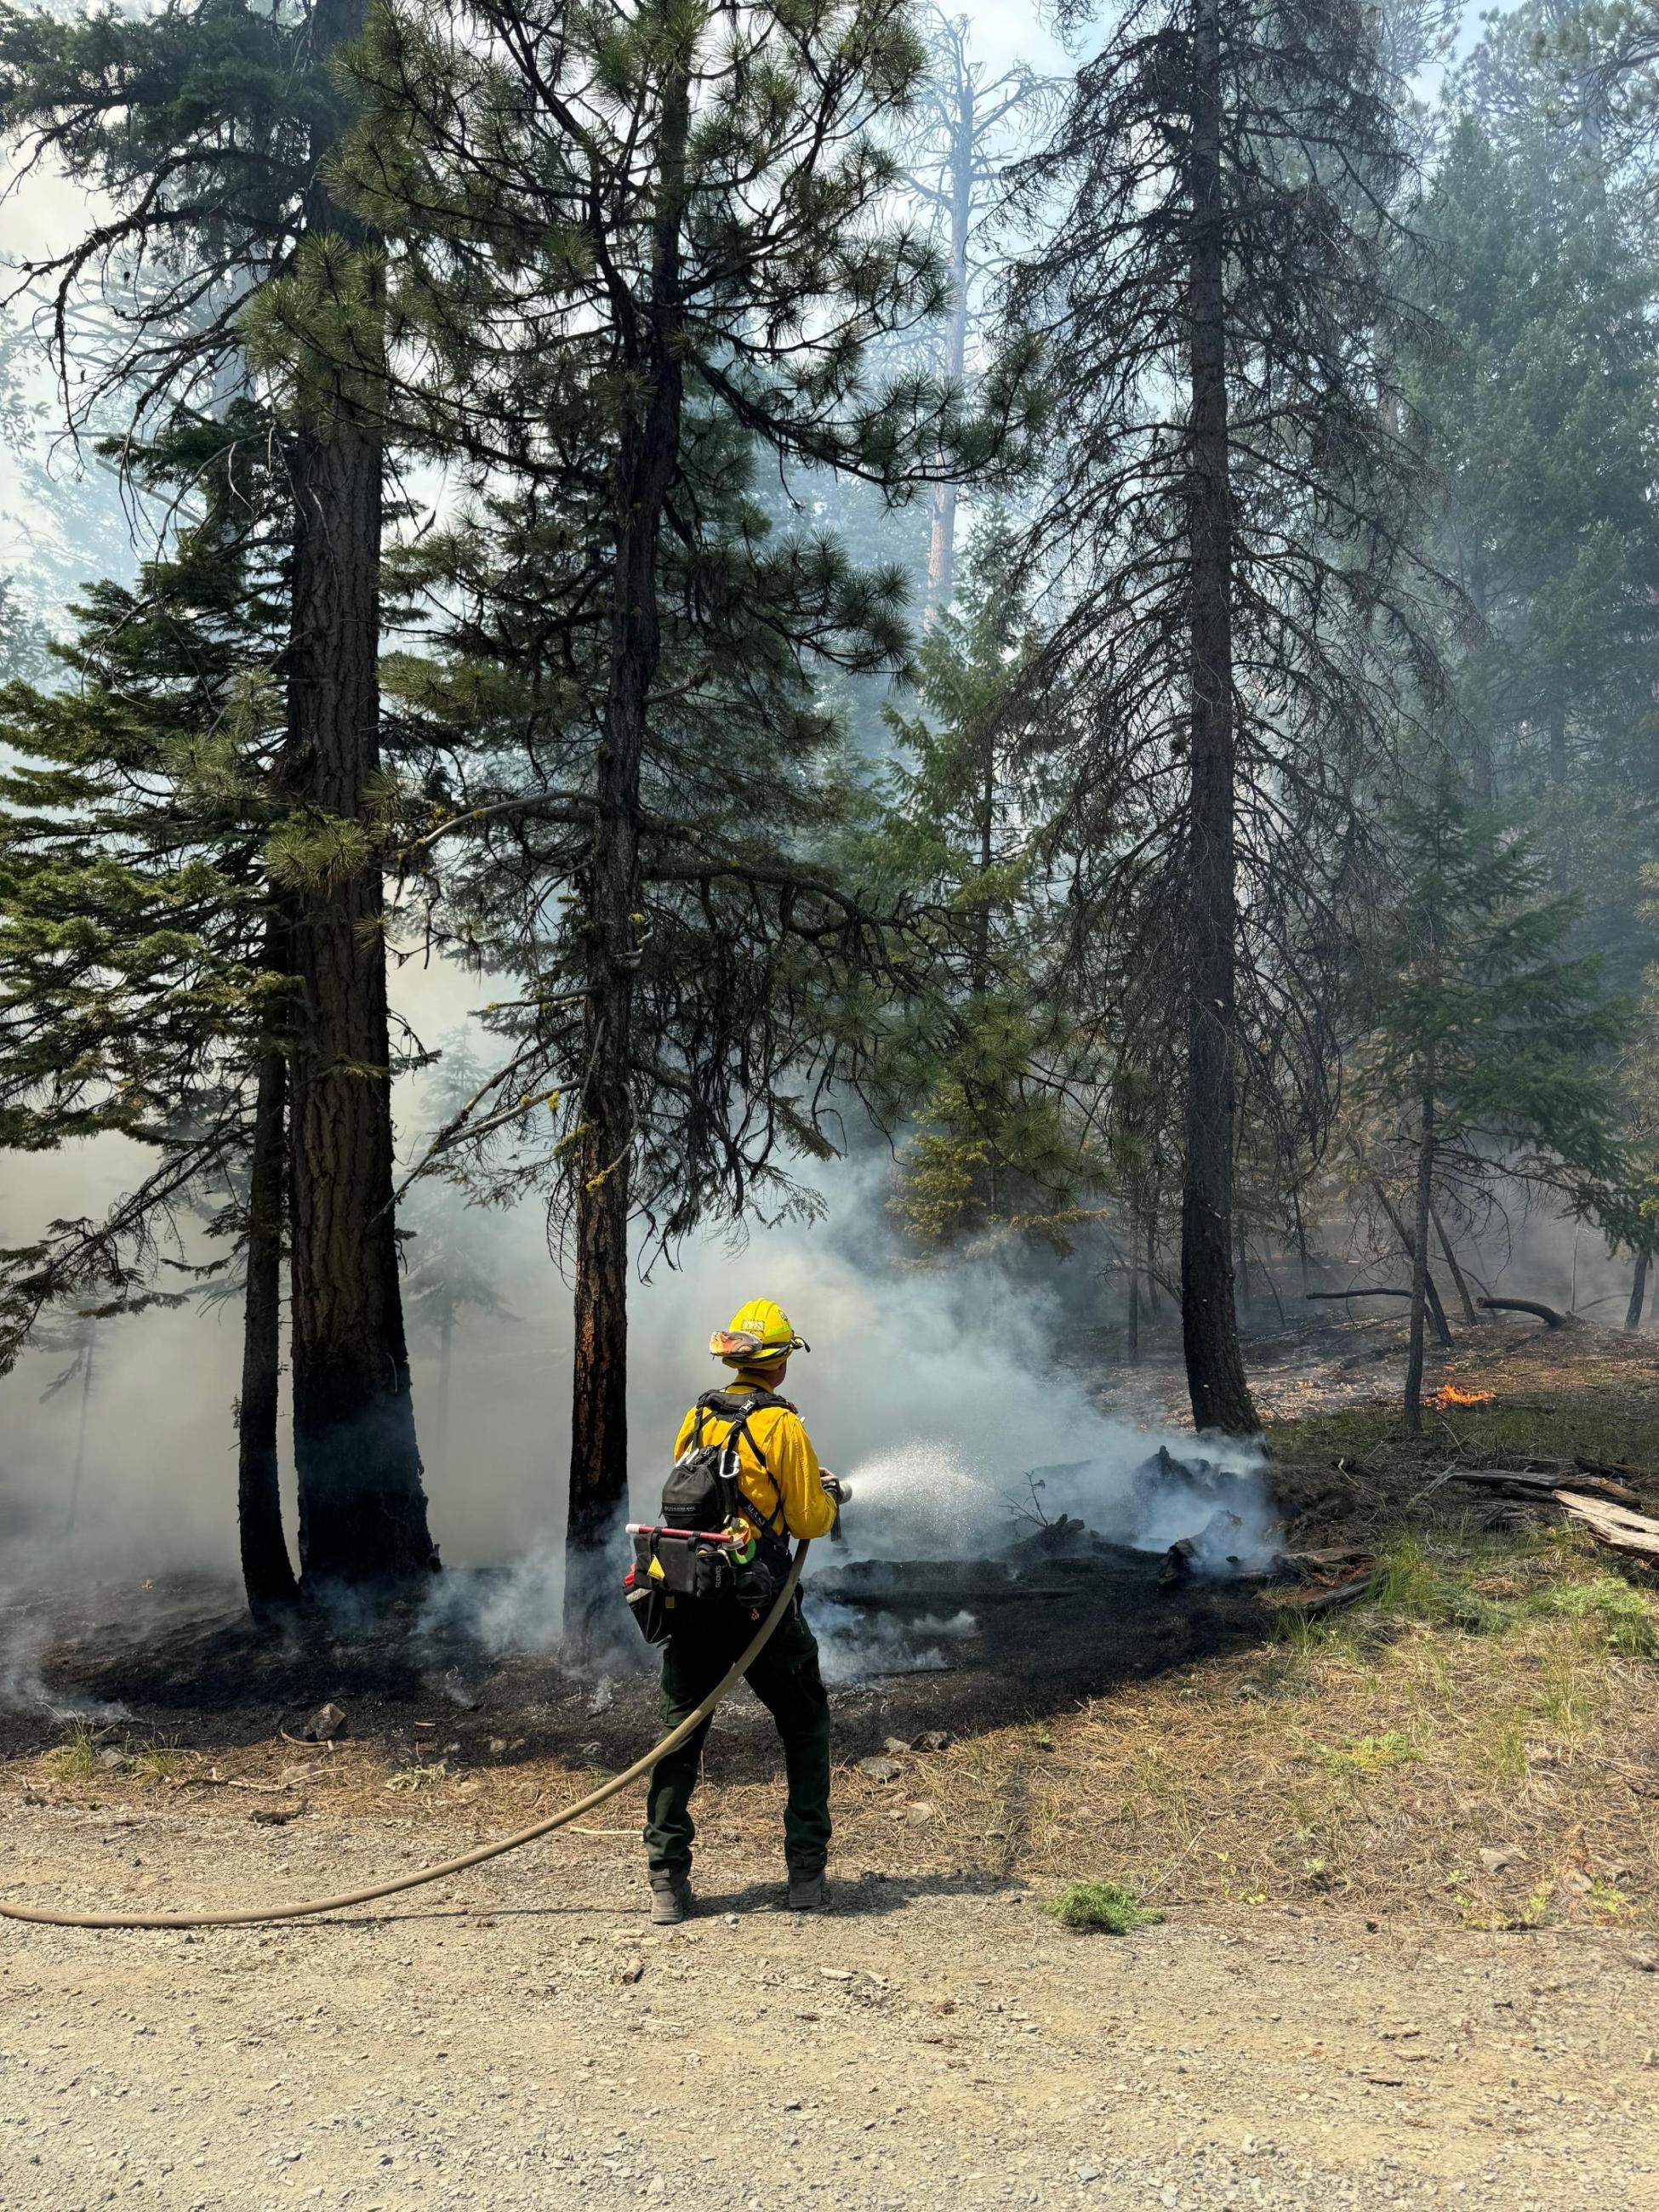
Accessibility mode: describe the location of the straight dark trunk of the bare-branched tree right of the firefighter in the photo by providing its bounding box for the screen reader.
[1181,0,1261,1435]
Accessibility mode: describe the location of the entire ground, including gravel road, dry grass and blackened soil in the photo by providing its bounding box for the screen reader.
[0,1316,1659,2212]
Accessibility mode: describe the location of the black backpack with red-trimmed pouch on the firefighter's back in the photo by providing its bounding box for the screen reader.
[622,1389,794,1644]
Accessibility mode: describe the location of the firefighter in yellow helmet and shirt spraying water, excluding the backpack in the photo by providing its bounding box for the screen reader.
[646,1298,838,1927]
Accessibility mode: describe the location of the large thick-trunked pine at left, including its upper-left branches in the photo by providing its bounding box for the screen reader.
[0,0,434,1582]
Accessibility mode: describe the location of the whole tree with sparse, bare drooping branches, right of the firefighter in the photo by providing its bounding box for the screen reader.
[1013,0,1422,1434]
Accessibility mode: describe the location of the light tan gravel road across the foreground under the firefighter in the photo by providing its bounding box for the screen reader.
[0,1799,1659,2212]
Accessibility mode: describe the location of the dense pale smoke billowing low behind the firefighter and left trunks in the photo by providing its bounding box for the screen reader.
[0,969,1265,1695]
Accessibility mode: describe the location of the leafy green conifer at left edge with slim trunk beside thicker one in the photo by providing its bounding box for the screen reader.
[0,407,294,1615]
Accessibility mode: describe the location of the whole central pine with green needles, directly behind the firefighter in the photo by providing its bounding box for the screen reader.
[321,0,1035,1626]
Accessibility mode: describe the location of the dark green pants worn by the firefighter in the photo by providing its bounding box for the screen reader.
[646,1606,830,1876]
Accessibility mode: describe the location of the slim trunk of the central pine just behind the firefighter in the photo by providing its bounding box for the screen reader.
[564,47,690,1645]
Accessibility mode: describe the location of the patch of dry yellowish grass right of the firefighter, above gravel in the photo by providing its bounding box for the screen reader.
[835,1531,1659,1929]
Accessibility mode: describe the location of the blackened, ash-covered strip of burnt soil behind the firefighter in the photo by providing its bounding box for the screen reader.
[0,1553,1263,1778]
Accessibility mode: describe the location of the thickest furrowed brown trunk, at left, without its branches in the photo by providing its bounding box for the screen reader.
[288,0,438,1586]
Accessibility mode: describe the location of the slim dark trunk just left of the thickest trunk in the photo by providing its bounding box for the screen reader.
[237,1026,299,1622]
